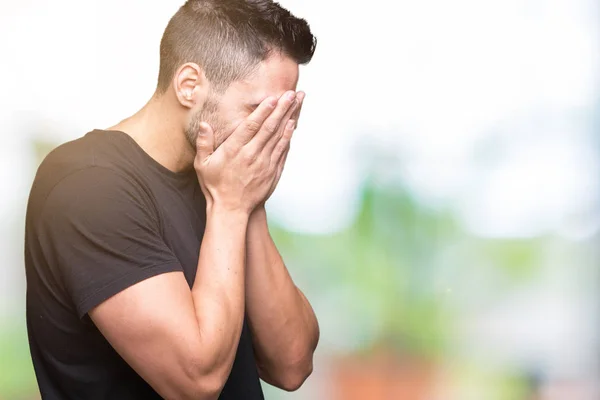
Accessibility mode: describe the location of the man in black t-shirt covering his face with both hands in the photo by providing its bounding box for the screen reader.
[25,0,319,400]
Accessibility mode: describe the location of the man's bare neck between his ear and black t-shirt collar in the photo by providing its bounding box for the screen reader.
[109,93,195,172]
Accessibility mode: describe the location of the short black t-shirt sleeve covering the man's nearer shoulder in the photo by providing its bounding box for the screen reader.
[37,167,182,318]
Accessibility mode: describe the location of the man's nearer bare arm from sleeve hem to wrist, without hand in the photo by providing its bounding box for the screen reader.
[90,210,248,399]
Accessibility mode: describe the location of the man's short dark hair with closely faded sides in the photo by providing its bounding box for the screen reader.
[157,0,317,94]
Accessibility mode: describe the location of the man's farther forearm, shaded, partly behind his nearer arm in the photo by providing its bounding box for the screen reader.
[246,208,319,388]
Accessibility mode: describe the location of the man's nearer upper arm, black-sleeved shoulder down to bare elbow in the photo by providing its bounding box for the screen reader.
[36,168,219,399]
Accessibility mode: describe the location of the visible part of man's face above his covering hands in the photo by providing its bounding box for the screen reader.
[186,53,298,148]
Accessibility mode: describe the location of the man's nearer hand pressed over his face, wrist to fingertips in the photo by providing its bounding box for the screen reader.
[194,91,297,214]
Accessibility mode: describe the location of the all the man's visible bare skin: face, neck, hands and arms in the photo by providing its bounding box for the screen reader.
[90,53,319,399]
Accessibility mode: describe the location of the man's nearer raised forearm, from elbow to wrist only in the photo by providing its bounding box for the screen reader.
[192,207,248,376]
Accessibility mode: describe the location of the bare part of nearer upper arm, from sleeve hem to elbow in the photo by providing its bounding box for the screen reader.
[89,272,221,399]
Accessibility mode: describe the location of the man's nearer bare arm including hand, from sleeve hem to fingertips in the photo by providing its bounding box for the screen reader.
[89,94,298,399]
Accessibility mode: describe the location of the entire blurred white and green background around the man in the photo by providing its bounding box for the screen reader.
[0,0,600,400]
